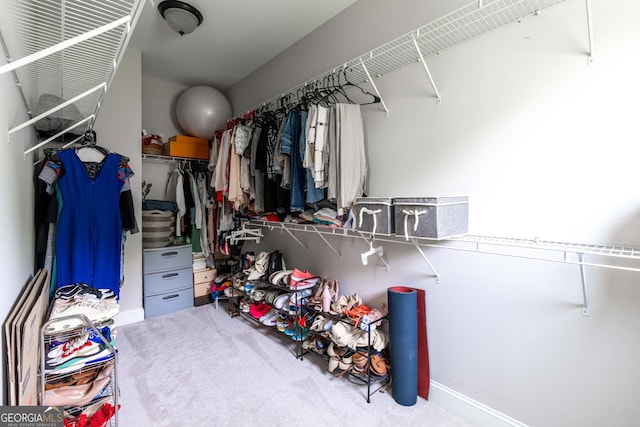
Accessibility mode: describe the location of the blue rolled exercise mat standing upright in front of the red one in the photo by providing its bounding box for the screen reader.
[387,286,418,406]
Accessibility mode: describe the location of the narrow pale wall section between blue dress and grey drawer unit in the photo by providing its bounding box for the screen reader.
[94,49,144,323]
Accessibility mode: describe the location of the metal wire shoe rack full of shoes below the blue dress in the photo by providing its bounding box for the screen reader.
[39,314,119,427]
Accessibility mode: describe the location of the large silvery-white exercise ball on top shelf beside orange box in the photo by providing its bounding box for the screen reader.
[176,86,231,139]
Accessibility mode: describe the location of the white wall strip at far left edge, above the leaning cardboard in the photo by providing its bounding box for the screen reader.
[0,51,35,408]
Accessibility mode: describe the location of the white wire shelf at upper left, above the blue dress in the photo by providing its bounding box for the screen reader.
[0,0,144,150]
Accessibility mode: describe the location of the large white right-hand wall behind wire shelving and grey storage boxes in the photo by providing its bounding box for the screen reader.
[228,0,640,426]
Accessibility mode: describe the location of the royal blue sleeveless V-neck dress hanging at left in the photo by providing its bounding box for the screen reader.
[56,150,123,295]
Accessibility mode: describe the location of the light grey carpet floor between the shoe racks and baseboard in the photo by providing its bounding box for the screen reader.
[116,303,468,427]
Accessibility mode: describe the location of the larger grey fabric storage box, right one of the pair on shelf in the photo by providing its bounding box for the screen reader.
[393,196,469,239]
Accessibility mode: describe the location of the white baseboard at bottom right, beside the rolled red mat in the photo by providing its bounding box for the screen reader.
[429,380,527,427]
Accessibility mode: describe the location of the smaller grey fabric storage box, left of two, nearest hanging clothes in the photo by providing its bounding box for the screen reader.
[356,197,395,236]
